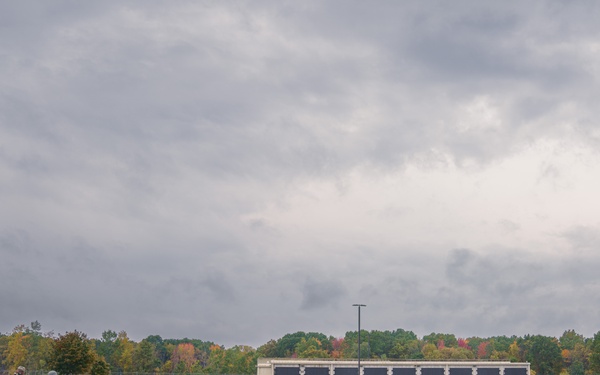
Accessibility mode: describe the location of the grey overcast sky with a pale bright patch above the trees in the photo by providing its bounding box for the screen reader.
[0,0,600,347]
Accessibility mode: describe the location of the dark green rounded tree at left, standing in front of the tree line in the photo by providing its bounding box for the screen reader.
[50,331,95,375]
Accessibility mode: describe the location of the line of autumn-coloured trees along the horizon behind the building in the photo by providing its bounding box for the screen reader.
[0,321,600,375]
